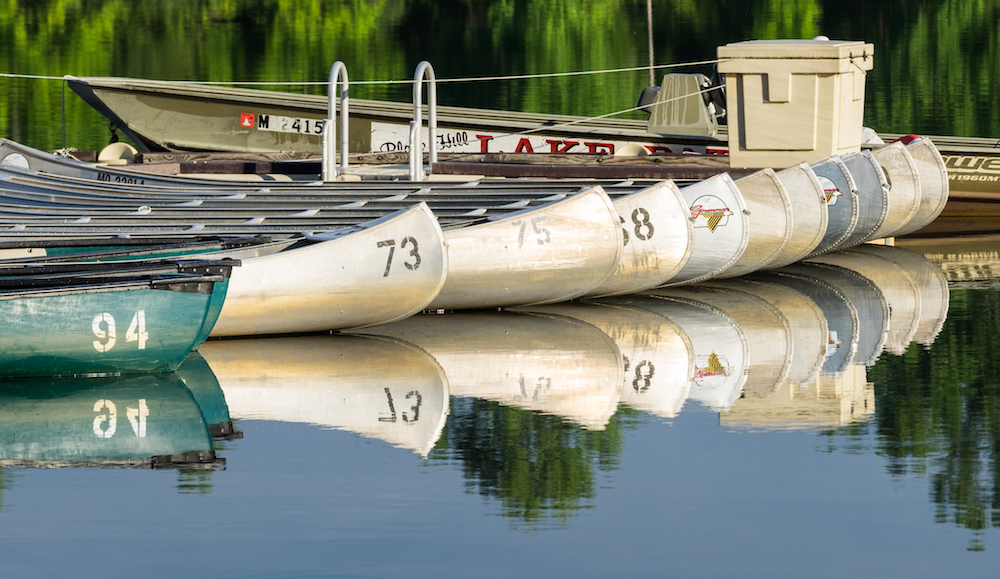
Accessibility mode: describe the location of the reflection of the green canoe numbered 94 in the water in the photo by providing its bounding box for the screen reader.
[0,373,225,469]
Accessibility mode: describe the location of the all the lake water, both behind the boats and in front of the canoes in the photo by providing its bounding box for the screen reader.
[0,0,1000,578]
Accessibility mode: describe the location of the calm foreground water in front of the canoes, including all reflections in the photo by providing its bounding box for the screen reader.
[0,242,1000,577]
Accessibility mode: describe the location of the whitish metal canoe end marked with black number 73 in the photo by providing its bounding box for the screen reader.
[211,203,448,336]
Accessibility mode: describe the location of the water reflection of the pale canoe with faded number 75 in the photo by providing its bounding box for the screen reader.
[358,312,623,430]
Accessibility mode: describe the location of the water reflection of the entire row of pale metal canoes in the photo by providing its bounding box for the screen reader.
[197,246,948,448]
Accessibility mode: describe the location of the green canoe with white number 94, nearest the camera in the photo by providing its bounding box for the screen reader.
[0,263,233,376]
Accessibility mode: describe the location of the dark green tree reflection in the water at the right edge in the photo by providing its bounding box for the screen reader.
[868,290,1000,548]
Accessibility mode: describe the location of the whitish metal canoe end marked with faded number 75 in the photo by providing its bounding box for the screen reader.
[430,187,623,310]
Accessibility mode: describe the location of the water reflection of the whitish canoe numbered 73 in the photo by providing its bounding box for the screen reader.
[200,335,449,456]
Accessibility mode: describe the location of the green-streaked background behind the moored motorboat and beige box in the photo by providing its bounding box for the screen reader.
[0,0,1000,149]
